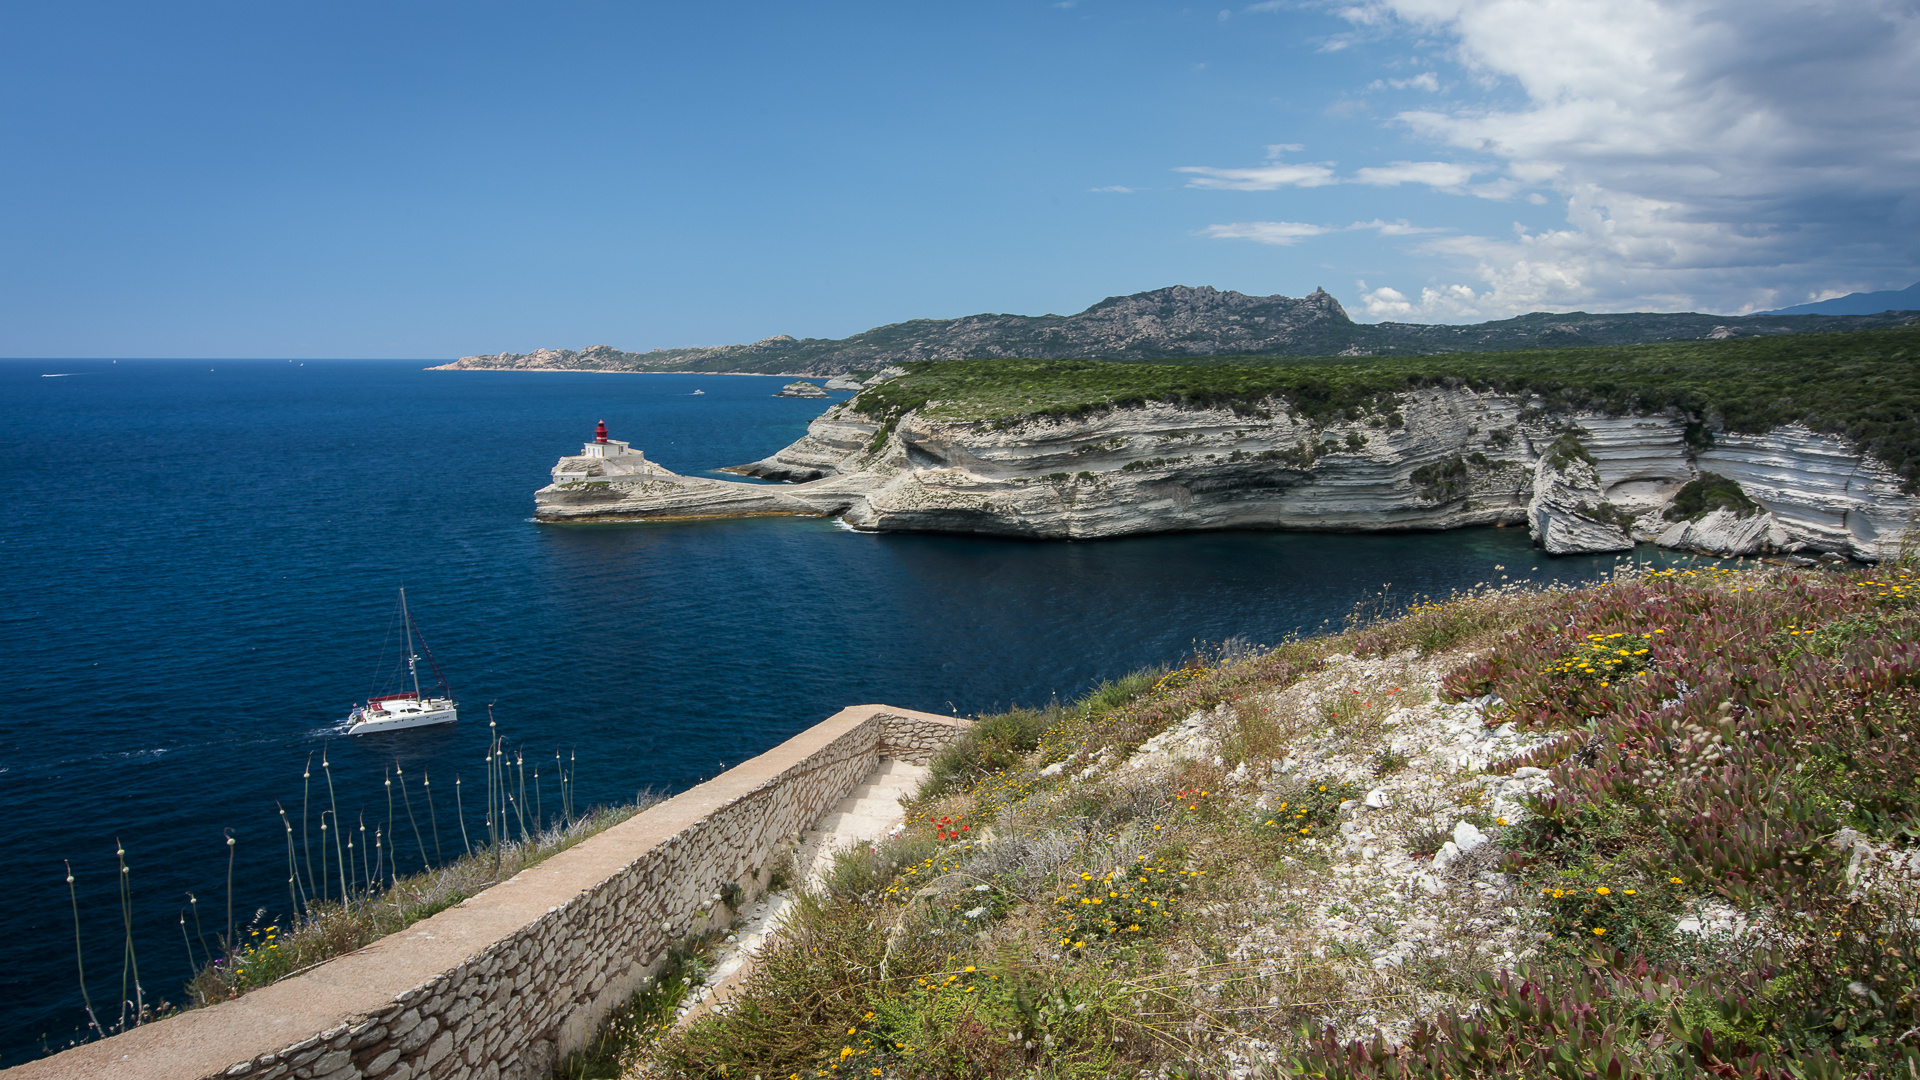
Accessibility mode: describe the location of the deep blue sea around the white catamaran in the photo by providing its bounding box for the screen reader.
[0,359,1712,1063]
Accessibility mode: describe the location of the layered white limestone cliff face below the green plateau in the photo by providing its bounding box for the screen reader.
[536,388,1916,559]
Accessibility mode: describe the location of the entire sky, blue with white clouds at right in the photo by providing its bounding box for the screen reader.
[0,0,1920,357]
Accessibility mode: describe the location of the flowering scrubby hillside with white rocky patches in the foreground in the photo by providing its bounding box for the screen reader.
[626,567,1920,1080]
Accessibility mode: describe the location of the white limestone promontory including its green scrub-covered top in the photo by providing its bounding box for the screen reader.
[536,329,1920,559]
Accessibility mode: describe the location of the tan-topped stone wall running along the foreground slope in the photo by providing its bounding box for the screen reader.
[8,705,966,1080]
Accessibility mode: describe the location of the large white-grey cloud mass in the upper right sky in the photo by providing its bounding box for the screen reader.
[1342,0,1920,319]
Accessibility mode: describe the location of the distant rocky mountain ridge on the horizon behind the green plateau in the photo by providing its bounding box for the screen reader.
[436,284,1914,377]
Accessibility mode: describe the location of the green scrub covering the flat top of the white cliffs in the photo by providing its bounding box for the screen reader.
[851,327,1920,486]
